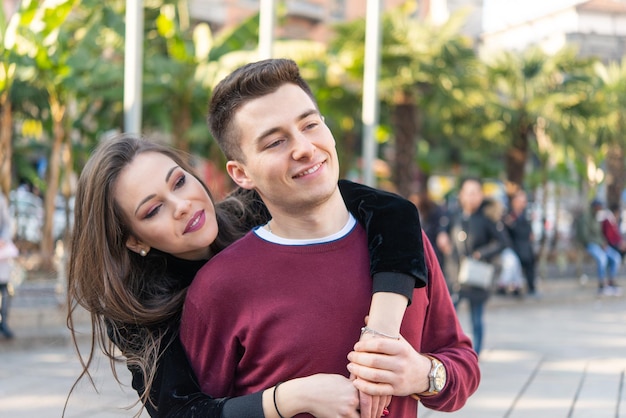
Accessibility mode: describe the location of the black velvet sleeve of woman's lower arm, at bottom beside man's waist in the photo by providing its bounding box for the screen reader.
[129,336,264,418]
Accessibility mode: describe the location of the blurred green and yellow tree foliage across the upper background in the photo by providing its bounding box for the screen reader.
[8,0,626,201]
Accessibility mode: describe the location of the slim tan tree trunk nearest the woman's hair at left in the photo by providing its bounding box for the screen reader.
[41,95,65,268]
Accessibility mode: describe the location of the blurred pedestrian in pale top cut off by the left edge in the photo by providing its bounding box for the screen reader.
[0,193,17,339]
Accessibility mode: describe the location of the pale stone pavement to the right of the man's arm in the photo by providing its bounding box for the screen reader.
[420,284,626,418]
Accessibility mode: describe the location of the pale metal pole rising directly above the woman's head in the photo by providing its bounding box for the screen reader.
[124,0,143,134]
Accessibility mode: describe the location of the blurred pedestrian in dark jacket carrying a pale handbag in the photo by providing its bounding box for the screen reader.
[449,177,507,354]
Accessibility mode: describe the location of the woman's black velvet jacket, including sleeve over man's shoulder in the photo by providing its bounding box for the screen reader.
[113,180,428,418]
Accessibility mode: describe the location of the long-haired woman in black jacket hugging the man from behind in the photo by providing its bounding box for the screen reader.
[68,135,427,417]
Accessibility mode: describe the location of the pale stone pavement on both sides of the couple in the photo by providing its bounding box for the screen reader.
[0,266,626,418]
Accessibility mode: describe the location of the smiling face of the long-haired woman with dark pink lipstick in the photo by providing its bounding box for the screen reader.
[113,152,218,260]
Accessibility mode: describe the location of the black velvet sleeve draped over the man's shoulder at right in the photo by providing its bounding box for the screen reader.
[339,180,428,299]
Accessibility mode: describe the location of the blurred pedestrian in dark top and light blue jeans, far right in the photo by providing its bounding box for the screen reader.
[574,199,622,296]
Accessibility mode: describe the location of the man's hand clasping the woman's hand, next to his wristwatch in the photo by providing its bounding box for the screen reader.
[348,337,431,396]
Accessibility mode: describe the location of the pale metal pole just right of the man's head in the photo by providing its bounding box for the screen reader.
[361,0,382,187]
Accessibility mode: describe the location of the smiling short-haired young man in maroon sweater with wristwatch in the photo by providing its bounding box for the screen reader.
[181,59,480,418]
